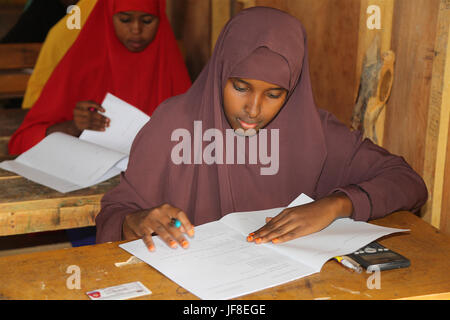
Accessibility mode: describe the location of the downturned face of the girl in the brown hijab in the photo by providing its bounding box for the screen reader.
[223,78,287,132]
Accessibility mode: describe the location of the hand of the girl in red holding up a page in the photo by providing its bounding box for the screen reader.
[73,101,110,131]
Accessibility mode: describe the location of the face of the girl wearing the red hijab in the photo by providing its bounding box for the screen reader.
[113,11,159,52]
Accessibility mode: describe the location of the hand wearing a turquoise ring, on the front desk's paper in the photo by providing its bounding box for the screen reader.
[122,204,194,251]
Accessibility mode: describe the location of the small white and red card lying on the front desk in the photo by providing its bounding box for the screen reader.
[86,281,152,300]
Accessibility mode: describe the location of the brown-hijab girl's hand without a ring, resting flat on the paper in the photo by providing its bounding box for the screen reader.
[247,193,353,244]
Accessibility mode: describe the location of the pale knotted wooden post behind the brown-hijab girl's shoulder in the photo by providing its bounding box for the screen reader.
[352,0,395,145]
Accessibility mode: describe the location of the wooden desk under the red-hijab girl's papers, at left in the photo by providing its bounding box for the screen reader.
[0,174,120,236]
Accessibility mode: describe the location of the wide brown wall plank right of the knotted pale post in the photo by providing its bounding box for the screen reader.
[384,0,439,182]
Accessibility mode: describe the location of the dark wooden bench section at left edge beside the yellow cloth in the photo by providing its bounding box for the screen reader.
[0,43,42,99]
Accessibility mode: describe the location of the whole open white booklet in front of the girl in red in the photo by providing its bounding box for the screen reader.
[0,93,150,193]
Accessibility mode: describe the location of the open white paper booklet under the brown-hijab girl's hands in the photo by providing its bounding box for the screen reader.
[120,195,407,300]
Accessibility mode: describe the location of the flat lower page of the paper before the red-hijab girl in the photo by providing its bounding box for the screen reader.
[0,132,127,193]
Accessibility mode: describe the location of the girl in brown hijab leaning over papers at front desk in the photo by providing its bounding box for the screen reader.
[96,7,427,250]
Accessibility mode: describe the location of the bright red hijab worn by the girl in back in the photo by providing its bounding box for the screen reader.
[9,0,191,154]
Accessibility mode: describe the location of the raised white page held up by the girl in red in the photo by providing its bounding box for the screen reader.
[80,93,150,154]
